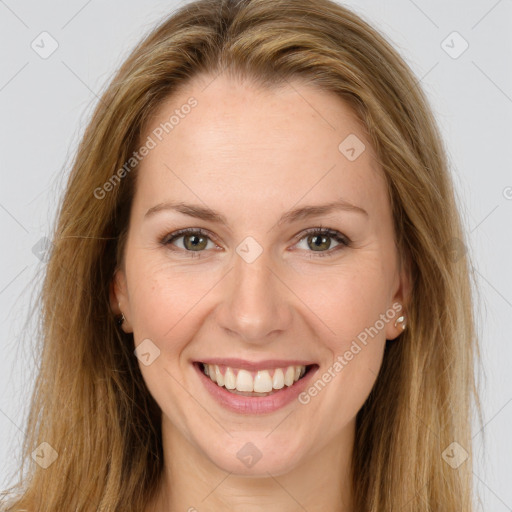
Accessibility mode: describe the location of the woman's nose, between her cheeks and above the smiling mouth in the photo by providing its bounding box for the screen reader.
[217,247,292,345]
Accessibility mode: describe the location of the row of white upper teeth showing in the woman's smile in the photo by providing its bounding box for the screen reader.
[203,364,306,393]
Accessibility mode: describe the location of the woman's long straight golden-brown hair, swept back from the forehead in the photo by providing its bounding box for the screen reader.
[2,0,480,512]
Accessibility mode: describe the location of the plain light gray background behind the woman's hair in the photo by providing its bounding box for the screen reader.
[0,0,512,512]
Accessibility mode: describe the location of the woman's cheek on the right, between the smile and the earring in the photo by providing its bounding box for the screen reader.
[296,253,388,408]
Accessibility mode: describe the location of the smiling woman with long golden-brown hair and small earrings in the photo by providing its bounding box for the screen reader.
[0,0,478,512]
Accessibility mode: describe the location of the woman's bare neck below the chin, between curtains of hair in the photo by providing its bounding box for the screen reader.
[146,419,355,512]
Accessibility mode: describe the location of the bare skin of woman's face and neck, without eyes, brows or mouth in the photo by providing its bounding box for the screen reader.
[112,75,410,512]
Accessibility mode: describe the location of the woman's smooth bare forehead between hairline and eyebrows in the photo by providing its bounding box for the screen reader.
[130,75,385,220]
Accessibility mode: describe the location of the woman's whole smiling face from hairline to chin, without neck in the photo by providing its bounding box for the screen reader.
[113,76,407,475]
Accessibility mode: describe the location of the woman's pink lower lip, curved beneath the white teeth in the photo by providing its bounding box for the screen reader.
[194,363,318,414]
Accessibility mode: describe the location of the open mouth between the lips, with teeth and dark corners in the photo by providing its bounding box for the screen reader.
[194,361,318,398]
